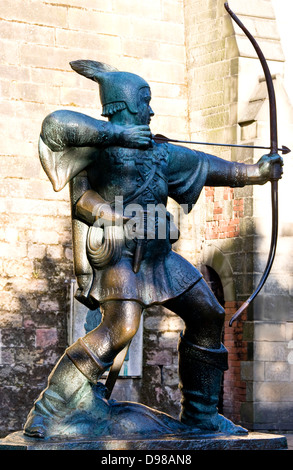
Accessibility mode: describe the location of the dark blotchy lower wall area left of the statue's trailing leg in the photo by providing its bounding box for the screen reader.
[0,256,72,437]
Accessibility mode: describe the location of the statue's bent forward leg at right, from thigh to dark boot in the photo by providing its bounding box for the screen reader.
[165,280,247,434]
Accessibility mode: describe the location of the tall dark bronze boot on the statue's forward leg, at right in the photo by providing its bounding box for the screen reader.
[178,335,247,434]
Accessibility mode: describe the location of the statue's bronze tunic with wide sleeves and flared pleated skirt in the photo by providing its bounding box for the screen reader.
[40,140,209,306]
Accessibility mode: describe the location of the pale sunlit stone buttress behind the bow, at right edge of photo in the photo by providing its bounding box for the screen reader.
[235,1,293,430]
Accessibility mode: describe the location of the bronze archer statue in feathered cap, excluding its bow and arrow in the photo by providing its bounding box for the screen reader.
[24,60,282,438]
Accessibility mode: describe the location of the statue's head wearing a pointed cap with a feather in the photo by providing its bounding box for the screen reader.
[70,60,154,124]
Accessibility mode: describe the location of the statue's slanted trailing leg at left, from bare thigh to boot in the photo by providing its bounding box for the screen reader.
[24,301,142,438]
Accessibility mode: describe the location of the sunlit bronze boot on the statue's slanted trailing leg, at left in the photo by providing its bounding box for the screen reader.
[23,338,111,438]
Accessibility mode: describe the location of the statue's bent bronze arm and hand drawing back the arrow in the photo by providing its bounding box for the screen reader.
[41,110,151,152]
